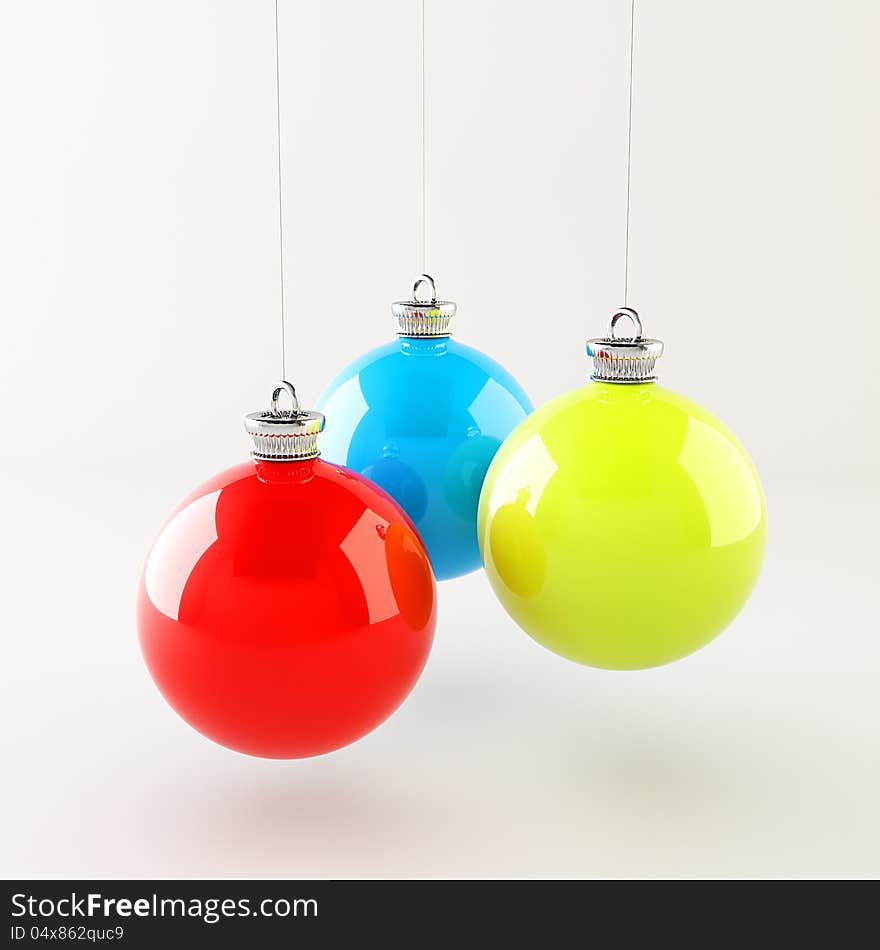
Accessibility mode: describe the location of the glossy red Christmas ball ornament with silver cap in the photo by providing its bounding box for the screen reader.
[138,382,436,758]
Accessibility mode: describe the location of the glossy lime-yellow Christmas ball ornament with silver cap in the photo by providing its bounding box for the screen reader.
[479,309,766,669]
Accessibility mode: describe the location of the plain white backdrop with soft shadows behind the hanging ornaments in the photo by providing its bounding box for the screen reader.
[0,0,880,877]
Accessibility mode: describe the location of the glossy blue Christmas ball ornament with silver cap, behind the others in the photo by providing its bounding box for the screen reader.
[318,274,532,580]
